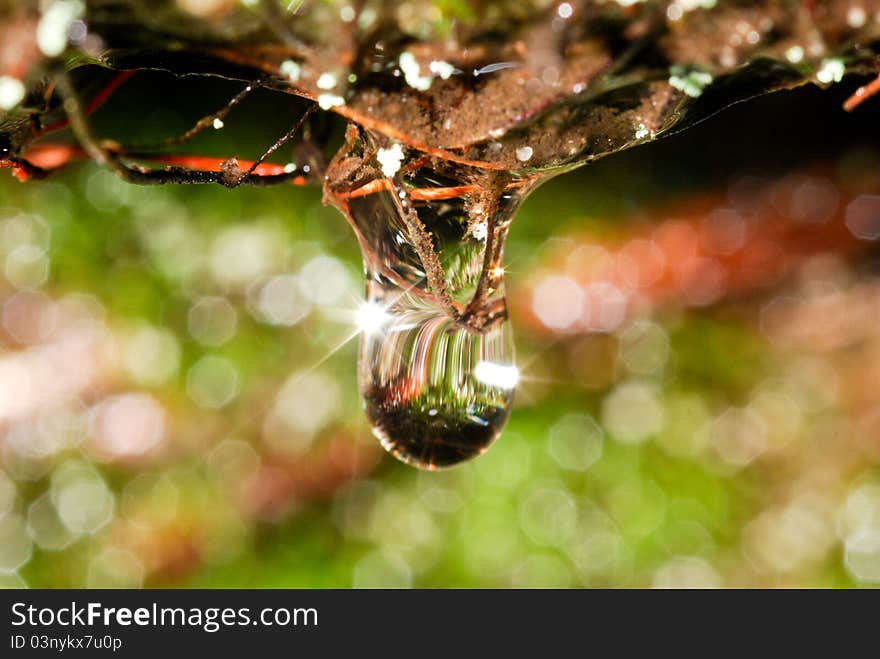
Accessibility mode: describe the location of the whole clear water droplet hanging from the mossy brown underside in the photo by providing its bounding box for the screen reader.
[328,129,530,469]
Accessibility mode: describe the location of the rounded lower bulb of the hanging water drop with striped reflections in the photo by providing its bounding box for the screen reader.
[359,311,516,468]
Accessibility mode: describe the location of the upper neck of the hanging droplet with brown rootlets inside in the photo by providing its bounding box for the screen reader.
[325,128,537,333]
